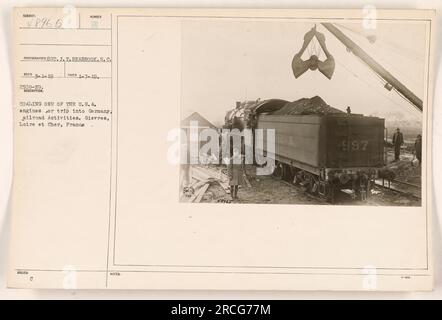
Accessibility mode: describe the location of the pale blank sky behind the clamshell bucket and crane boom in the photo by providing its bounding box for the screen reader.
[182,20,426,124]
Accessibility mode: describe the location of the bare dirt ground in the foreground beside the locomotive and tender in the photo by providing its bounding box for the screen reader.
[201,166,421,206]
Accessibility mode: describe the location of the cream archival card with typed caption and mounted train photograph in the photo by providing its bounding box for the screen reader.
[0,3,441,296]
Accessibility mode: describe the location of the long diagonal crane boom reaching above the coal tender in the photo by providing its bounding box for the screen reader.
[322,22,423,112]
